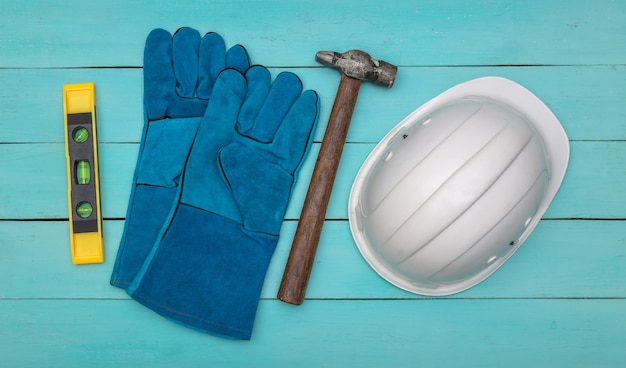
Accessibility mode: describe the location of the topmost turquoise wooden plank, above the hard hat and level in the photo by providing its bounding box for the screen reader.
[0,0,626,68]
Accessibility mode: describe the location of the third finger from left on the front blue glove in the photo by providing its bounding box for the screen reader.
[247,72,302,143]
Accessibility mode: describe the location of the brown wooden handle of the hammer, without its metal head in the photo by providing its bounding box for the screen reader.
[278,74,361,304]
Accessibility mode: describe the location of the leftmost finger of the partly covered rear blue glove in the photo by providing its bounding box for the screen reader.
[143,29,176,120]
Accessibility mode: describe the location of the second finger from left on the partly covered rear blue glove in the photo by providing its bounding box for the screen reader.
[172,27,200,98]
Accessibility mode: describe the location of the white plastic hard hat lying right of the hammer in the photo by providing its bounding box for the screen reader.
[349,77,569,295]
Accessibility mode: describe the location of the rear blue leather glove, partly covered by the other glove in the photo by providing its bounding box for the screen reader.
[111,28,250,288]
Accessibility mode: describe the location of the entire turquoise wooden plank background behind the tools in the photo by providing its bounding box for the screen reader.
[0,0,626,367]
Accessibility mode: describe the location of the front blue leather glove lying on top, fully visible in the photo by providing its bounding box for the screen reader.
[126,66,319,339]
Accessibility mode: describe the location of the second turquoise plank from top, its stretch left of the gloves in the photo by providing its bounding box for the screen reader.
[0,69,143,143]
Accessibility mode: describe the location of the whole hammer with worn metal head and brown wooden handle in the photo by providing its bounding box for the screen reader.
[278,50,398,305]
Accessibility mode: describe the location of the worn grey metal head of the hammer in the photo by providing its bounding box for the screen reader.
[315,50,398,88]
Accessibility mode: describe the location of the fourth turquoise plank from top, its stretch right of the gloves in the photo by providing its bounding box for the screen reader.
[280,220,626,299]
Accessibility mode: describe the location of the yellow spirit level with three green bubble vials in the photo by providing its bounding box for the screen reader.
[63,83,104,264]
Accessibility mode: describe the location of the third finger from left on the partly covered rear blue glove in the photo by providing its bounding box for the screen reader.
[197,32,226,99]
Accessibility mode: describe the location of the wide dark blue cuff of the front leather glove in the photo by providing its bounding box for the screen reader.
[127,204,278,340]
